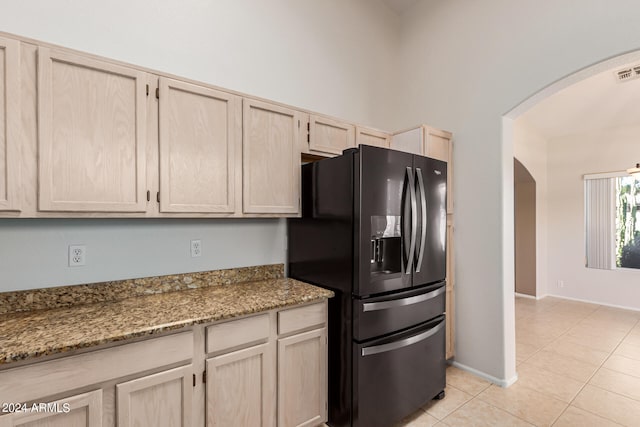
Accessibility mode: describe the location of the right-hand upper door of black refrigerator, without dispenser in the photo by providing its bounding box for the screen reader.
[413,156,447,286]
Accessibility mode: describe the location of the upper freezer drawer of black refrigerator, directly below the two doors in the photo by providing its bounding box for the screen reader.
[353,282,446,341]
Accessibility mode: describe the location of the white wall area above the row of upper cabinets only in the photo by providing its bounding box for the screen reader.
[0,0,399,126]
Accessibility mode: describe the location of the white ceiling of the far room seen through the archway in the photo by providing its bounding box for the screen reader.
[521,63,640,139]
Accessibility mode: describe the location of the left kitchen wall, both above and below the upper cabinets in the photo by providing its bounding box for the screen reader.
[0,0,398,292]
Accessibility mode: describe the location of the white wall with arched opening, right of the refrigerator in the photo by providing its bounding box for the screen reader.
[390,0,640,382]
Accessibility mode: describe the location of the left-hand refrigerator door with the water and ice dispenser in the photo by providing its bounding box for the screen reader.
[353,145,418,296]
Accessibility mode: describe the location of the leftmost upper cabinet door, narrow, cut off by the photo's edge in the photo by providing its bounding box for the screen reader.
[0,37,20,211]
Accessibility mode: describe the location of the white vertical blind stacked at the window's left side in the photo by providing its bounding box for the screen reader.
[585,178,615,270]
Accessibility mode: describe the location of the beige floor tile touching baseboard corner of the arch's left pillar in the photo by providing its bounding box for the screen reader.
[477,383,567,426]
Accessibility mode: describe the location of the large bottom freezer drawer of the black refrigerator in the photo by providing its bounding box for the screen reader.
[353,316,446,427]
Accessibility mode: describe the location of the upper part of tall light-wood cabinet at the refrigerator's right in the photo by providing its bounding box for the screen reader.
[390,125,453,214]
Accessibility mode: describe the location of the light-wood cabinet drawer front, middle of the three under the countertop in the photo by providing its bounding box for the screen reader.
[206,314,269,353]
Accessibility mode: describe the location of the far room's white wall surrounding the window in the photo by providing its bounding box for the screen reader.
[548,125,640,310]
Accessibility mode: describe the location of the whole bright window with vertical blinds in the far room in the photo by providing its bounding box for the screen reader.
[585,173,640,270]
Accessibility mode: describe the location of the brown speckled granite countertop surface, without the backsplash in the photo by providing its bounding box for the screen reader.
[0,278,333,368]
